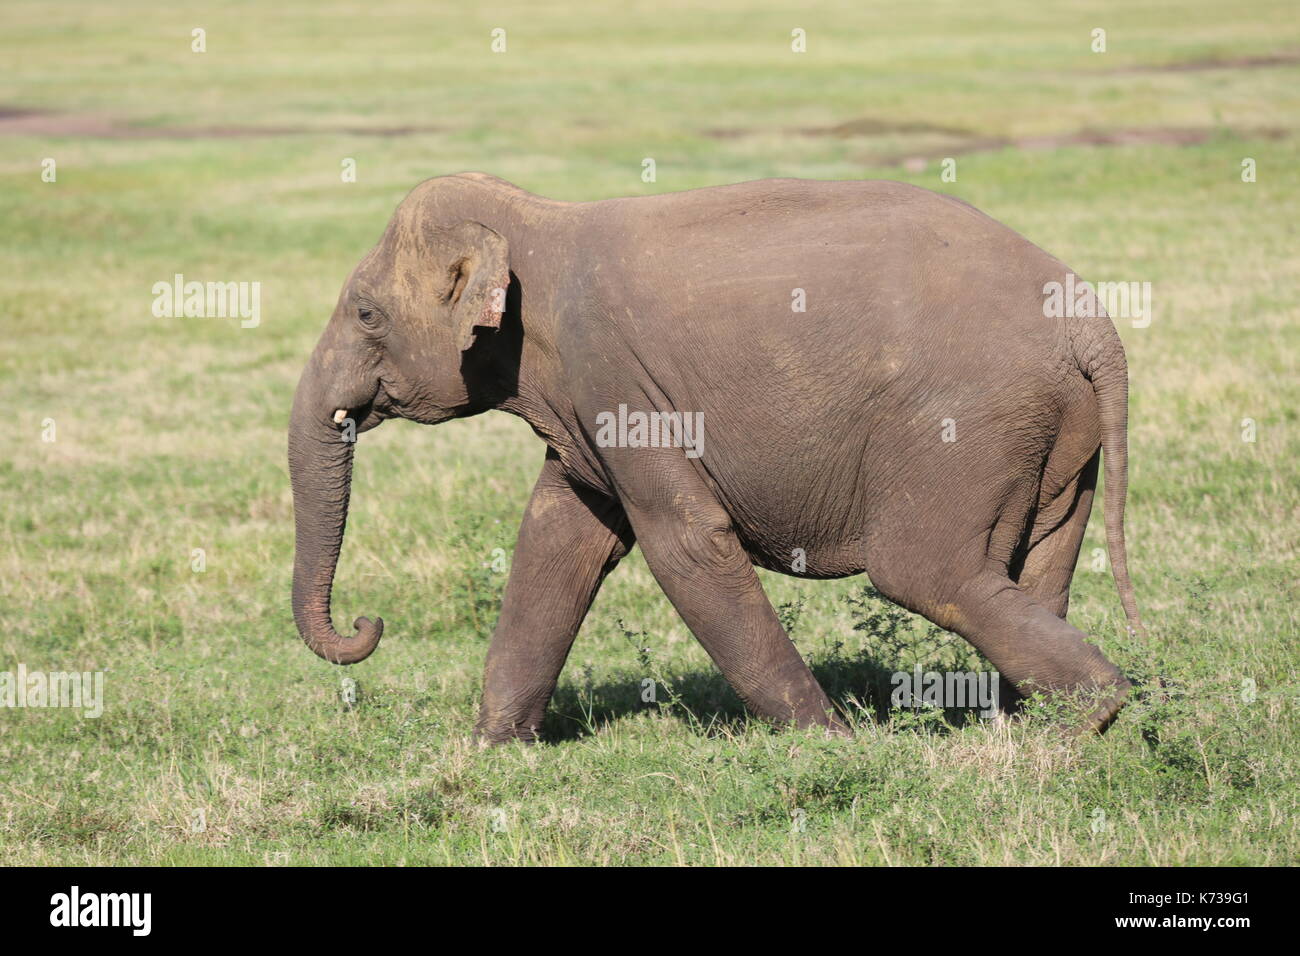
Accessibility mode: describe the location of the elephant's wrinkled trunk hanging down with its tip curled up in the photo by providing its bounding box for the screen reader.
[289,363,384,663]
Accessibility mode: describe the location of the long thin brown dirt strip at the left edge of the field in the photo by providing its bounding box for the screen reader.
[0,107,443,139]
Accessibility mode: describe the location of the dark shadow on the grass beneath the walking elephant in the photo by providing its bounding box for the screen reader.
[542,656,930,743]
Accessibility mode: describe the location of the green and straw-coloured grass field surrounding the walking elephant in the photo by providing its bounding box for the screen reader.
[0,0,1300,865]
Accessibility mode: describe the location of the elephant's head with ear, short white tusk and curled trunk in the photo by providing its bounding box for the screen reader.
[289,195,510,663]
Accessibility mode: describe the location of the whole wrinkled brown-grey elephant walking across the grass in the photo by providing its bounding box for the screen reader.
[289,173,1138,741]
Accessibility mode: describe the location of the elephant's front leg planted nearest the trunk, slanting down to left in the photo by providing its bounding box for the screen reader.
[475,451,634,743]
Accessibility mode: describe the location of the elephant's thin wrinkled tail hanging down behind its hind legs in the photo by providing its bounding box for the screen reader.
[1066,308,1144,633]
